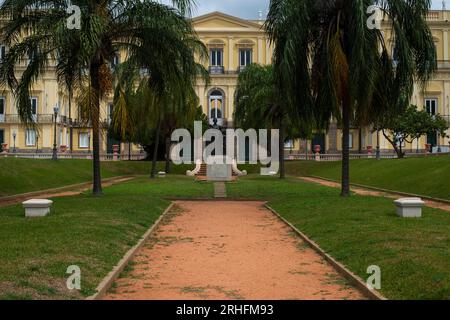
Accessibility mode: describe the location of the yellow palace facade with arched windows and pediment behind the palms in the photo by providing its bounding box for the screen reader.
[0,11,450,154]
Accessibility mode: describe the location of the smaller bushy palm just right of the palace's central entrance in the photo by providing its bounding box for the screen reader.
[234,64,308,179]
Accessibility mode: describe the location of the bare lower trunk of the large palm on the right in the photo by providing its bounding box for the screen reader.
[341,102,350,197]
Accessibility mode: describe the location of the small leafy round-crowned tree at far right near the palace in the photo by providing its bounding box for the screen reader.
[376,105,449,158]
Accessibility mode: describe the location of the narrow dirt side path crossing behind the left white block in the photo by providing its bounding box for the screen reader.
[0,177,134,208]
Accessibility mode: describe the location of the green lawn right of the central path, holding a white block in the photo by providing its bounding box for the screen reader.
[227,176,450,299]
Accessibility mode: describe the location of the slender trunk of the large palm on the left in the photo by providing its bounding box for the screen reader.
[90,60,103,196]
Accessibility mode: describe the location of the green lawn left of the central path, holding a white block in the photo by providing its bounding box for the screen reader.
[0,177,213,299]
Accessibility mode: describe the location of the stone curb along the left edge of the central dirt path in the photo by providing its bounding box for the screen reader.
[86,203,174,300]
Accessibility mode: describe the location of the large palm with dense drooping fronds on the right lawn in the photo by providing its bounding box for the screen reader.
[265,0,436,196]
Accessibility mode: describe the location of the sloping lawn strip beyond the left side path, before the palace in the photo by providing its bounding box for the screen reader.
[0,157,194,197]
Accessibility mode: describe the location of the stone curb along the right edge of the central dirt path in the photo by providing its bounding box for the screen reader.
[265,204,387,300]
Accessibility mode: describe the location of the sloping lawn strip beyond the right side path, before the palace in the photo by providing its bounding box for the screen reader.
[287,156,450,200]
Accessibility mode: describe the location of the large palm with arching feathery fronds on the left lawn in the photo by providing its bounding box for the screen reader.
[0,0,200,195]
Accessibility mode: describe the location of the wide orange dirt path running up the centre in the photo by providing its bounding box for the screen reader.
[104,201,364,300]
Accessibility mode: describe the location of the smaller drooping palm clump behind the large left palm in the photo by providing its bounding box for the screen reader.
[112,48,209,178]
